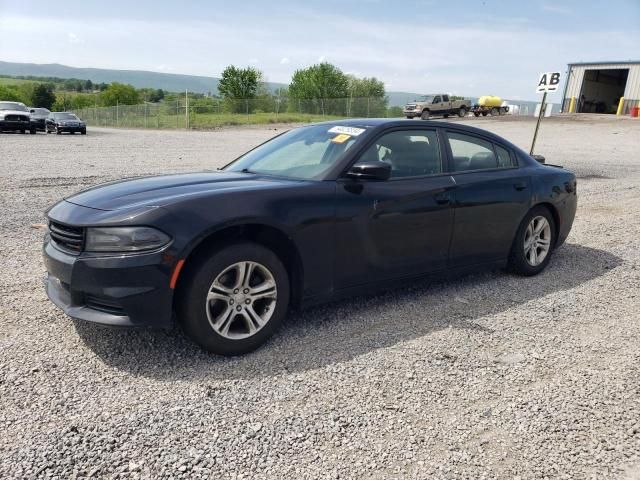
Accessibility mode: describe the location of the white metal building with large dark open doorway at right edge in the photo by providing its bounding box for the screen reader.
[562,61,640,114]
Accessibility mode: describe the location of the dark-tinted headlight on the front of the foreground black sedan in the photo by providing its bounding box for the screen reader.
[85,227,171,252]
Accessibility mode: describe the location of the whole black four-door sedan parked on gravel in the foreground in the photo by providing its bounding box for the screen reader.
[44,119,577,355]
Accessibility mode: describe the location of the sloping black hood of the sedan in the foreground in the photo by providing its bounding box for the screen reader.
[65,172,301,210]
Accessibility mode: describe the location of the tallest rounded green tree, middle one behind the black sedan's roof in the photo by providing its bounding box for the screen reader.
[289,62,349,114]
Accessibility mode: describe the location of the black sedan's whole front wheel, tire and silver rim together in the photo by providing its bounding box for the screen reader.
[177,243,289,356]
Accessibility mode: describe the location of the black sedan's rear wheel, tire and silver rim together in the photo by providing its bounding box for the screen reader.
[507,206,557,276]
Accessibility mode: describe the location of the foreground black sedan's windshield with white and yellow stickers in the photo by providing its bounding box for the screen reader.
[223,124,365,179]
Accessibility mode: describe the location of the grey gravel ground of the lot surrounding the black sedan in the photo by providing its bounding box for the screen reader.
[0,117,640,479]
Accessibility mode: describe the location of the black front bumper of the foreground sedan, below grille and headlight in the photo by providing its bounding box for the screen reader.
[43,238,173,328]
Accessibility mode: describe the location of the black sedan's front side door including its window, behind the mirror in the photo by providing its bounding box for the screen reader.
[335,129,455,288]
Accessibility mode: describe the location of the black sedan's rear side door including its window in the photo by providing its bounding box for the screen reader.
[445,130,531,267]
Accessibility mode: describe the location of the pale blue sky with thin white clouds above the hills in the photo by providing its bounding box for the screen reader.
[0,0,640,99]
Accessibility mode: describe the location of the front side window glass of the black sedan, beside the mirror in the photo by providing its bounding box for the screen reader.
[357,130,442,178]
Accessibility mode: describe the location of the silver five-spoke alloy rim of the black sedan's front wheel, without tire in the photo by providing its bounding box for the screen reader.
[205,261,278,340]
